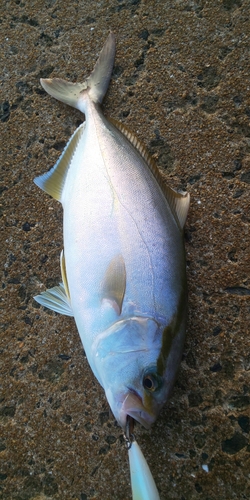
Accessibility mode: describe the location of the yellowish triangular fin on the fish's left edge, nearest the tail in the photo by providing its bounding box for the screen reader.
[34,123,85,201]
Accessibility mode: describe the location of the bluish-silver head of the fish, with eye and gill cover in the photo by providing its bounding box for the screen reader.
[92,316,184,429]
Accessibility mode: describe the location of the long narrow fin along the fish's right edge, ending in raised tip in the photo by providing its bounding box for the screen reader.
[109,117,190,229]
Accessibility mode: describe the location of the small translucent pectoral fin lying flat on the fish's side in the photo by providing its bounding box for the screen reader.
[101,255,126,314]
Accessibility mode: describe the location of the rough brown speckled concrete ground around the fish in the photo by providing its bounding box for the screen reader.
[0,0,250,500]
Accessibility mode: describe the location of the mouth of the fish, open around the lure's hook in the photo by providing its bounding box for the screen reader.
[119,389,156,429]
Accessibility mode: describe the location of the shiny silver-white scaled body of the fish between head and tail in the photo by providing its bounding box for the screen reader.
[62,102,183,330]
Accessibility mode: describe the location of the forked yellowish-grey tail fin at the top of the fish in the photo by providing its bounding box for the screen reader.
[40,33,115,112]
